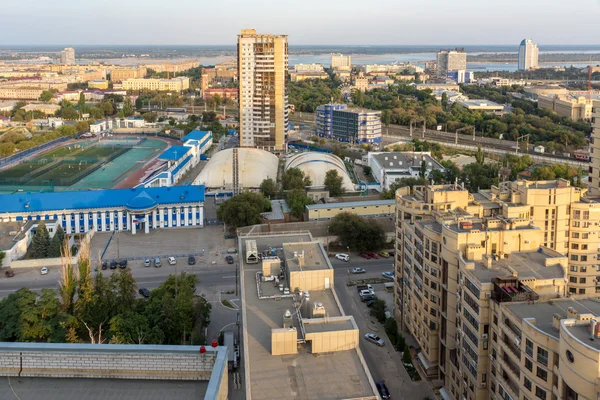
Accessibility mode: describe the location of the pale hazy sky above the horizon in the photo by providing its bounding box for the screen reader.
[0,0,600,45]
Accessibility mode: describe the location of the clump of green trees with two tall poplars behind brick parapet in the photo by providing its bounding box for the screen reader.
[0,242,211,344]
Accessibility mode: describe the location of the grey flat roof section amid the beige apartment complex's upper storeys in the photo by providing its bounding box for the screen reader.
[469,251,566,282]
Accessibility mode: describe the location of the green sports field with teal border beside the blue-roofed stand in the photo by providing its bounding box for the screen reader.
[0,137,169,193]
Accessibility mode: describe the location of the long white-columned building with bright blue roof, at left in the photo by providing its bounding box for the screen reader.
[0,186,204,234]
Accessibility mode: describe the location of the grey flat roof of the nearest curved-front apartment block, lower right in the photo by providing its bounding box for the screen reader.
[503,298,600,342]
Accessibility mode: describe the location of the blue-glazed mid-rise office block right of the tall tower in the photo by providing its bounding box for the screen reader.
[316,104,381,144]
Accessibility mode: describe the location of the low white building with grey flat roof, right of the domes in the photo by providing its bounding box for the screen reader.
[367,152,444,192]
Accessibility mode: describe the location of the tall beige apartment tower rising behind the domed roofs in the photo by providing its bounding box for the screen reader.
[238,29,288,151]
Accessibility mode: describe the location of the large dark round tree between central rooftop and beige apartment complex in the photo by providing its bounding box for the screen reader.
[329,212,386,251]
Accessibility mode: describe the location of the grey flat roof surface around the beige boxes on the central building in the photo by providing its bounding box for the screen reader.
[240,233,374,400]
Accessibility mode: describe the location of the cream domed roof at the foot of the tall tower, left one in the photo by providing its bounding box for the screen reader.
[194,148,279,189]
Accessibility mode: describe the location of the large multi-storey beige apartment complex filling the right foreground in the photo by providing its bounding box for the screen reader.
[395,180,600,400]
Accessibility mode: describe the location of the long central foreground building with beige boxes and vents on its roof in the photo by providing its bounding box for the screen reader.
[238,233,379,400]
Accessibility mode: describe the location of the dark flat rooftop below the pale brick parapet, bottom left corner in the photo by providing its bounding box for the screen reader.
[0,377,208,400]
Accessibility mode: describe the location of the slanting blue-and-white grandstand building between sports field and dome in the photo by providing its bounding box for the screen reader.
[140,130,213,187]
